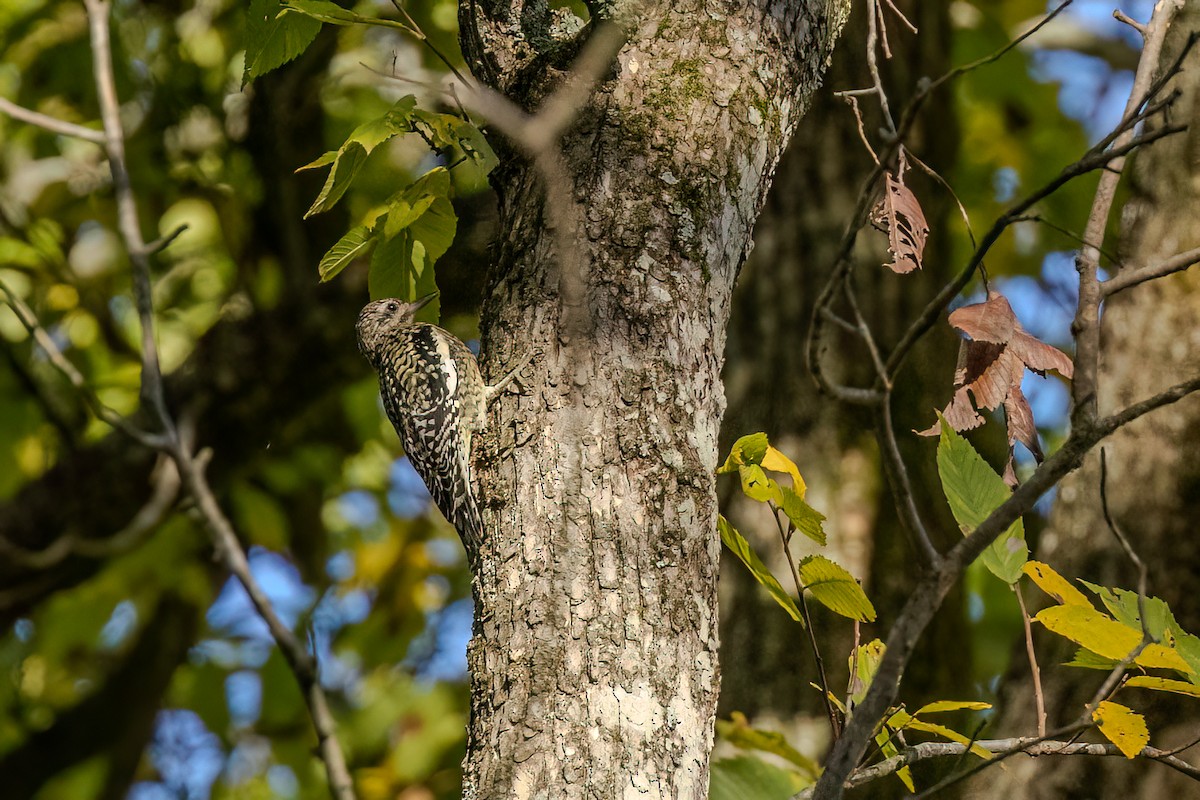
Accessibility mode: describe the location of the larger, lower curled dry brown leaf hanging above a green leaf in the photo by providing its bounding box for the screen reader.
[918,291,1074,485]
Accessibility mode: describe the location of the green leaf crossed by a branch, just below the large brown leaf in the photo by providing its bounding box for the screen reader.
[937,417,1030,584]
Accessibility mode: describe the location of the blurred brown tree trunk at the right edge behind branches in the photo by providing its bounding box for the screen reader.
[971,9,1200,800]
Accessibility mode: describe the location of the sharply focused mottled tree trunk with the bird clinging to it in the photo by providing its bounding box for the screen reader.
[461,0,847,799]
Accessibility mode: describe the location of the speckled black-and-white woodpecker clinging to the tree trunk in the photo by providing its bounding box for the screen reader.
[355,293,528,557]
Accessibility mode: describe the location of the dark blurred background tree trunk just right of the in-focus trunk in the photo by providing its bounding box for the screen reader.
[720,2,970,738]
